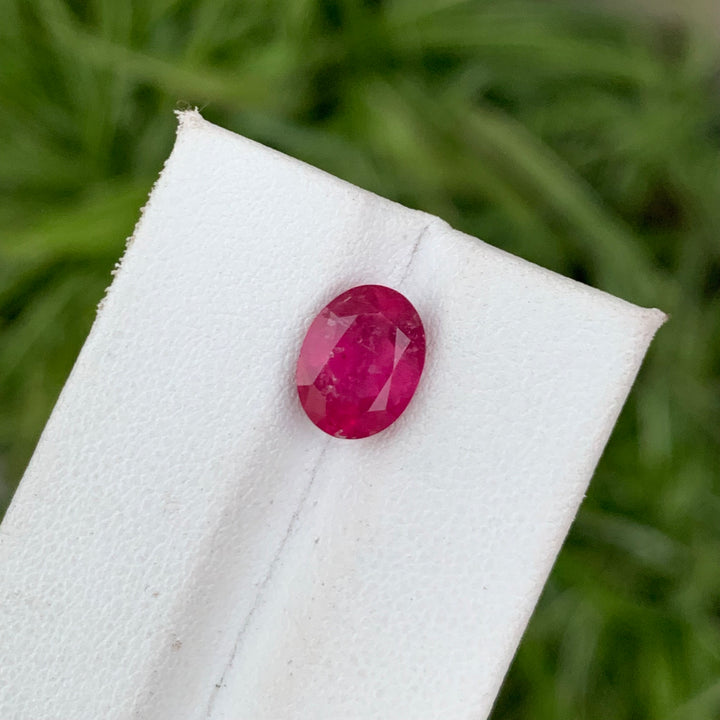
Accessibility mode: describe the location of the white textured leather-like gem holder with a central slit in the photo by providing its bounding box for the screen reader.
[0,113,664,720]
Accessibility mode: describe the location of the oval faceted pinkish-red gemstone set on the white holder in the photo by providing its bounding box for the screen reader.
[295,285,425,438]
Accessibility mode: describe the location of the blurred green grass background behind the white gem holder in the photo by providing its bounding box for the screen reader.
[0,0,720,720]
